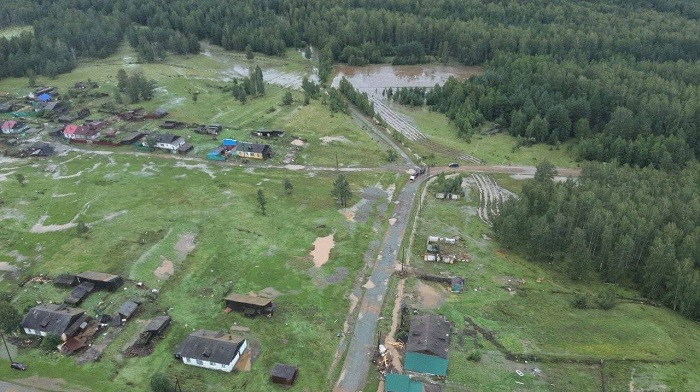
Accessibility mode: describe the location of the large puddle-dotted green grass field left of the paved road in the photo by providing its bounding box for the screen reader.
[0,153,395,391]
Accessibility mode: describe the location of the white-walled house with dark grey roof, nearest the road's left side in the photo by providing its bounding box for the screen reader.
[175,329,248,373]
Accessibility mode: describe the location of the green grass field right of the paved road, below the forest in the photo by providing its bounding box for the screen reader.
[404,175,700,391]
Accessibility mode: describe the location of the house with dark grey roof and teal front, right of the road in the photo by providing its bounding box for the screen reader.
[404,314,450,376]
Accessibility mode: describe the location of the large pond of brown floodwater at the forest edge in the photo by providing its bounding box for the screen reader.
[331,64,484,90]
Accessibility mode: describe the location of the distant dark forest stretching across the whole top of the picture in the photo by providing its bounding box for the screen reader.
[0,0,700,76]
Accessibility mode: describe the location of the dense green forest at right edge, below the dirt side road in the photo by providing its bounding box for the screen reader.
[493,163,700,320]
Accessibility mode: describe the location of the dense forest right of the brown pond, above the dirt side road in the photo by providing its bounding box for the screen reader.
[426,54,700,169]
